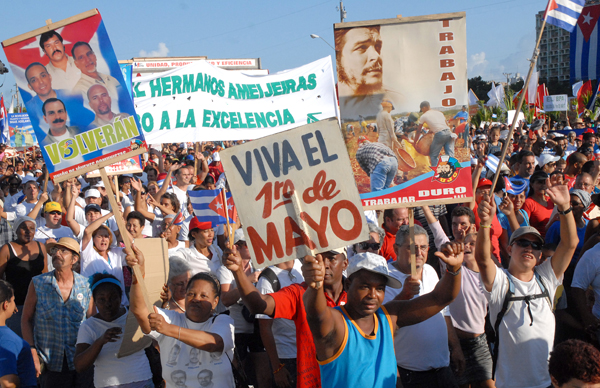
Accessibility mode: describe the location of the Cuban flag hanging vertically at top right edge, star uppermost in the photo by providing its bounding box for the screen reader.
[568,5,600,83]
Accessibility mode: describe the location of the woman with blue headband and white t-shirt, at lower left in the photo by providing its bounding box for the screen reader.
[75,273,154,388]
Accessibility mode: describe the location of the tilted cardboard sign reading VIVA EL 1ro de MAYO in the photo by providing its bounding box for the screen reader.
[220,118,369,268]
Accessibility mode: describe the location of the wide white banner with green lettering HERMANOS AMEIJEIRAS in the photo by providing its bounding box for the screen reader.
[133,57,337,143]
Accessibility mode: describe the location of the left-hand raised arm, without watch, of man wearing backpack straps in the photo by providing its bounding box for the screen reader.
[475,194,496,292]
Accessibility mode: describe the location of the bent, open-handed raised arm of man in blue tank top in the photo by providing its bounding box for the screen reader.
[385,243,464,327]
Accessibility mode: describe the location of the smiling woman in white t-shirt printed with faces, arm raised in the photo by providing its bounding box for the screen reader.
[127,246,235,388]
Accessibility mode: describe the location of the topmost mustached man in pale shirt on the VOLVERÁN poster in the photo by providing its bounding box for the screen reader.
[40,30,81,90]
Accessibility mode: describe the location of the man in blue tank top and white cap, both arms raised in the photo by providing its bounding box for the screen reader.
[302,249,463,388]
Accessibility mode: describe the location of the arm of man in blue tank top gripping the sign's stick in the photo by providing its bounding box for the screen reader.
[302,255,345,360]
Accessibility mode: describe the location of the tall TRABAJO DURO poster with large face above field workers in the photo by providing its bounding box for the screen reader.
[334,12,472,209]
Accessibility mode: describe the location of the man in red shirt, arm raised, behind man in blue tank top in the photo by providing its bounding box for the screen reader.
[223,246,348,388]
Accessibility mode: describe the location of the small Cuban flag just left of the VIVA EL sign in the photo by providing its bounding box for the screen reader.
[188,190,236,227]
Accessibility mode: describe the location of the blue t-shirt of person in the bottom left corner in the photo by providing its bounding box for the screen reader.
[0,326,37,388]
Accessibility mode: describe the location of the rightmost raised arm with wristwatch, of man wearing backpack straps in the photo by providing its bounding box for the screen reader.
[546,175,579,278]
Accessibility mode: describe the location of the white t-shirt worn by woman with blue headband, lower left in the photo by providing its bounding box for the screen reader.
[77,313,152,388]
